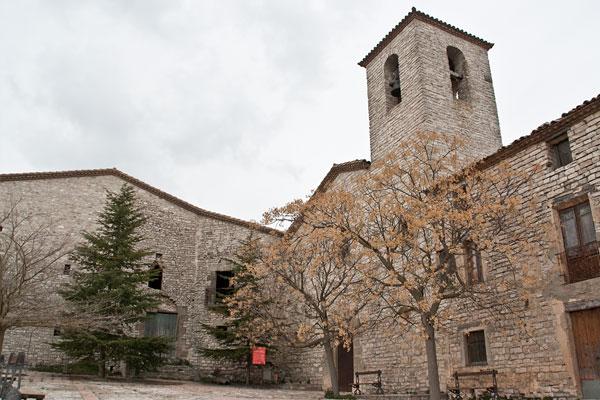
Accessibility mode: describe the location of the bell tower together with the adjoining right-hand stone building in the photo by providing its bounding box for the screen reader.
[282,9,600,398]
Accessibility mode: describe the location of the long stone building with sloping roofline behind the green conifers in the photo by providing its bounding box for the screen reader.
[0,169,280,374]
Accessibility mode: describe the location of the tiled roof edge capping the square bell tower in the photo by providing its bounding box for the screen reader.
[358,7,494,67]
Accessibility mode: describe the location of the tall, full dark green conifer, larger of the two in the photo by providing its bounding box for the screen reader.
[55,185,171,377]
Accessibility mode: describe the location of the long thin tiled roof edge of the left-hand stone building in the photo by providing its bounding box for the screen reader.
[0,168,283,236]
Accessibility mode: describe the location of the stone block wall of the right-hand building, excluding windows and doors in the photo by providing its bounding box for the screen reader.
[324,107,600,397]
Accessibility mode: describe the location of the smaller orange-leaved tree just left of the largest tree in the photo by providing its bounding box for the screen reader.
[230,233,376,395]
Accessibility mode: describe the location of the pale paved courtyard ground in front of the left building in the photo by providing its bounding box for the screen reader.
[21,373,322,400]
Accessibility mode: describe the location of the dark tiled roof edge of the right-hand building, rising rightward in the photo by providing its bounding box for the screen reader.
[477,94,600,168]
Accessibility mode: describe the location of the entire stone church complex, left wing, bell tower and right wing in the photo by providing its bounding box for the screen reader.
[0,8,600,398]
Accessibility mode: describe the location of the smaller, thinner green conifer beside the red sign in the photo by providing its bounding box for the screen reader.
[198,235,268,384]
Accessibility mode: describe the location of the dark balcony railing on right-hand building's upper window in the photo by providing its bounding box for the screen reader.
[561,242,600,283]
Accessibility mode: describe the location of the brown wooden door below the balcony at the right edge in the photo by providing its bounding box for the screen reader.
[571,307,600,399]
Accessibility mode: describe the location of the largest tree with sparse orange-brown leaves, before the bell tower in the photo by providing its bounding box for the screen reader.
[262,133,539,400]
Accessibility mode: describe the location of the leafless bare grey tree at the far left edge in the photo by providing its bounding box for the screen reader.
[0,199,68,351]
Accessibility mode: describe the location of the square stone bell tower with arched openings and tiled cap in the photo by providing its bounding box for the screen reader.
[359,8,502,161]
